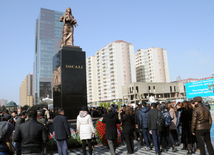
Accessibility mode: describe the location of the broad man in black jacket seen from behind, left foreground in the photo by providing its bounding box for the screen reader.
[14,110,48,155]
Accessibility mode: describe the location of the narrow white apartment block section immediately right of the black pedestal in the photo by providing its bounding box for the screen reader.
[86,56,98,103]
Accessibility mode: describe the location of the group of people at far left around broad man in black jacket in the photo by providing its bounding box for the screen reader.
[0,107,50,155]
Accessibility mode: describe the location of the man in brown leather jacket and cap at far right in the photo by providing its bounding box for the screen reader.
[191,97,214,155]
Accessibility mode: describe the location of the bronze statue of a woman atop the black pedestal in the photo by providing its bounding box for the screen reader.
[59,7,78,47]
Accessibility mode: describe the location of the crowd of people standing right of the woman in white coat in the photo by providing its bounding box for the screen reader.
[87,97,214,155]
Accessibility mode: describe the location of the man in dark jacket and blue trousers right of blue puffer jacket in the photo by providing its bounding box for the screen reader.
[148,103,162,155]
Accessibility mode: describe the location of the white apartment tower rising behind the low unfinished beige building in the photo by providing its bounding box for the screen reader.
[135,47,170,82]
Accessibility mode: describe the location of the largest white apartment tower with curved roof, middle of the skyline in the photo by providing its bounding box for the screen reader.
[91,40,136,102]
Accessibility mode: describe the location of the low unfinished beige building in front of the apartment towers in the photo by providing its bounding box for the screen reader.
[122,82,186,103]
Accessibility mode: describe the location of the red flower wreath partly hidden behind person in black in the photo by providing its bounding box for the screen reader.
[96,118,122,146]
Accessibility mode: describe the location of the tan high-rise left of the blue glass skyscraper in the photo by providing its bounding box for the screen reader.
[19,74,33,106]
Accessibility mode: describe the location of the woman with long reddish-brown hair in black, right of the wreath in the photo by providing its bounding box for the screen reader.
[121,106,135,154]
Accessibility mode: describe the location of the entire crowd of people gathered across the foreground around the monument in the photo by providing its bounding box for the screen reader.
[0,97,214,155]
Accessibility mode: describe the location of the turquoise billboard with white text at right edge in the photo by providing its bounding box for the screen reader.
[185,78,214,98]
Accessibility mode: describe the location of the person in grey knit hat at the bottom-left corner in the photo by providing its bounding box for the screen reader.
[0,121,14,155]
